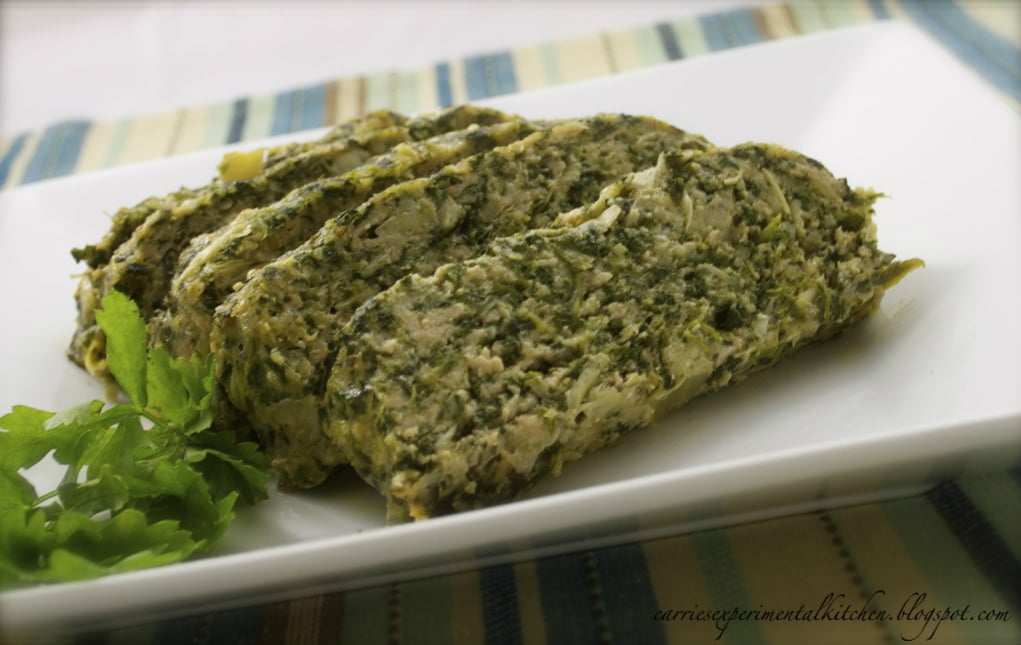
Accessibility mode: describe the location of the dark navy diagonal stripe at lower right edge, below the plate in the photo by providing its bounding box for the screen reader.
[926,481,1021,607]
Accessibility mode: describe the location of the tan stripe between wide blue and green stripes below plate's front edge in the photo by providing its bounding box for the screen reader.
[642,536,719,644]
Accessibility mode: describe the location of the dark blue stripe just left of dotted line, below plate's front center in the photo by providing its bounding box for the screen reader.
[535,553,599,643]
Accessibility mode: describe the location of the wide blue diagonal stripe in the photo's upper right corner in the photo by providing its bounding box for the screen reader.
[901,1,1021,101]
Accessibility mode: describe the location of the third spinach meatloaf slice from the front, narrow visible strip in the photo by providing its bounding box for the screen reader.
[149,119,537,356]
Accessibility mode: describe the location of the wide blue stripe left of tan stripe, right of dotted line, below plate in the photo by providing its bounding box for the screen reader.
[594,543,667,644]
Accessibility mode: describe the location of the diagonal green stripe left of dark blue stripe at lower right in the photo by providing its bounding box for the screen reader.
[879,497,1009,643]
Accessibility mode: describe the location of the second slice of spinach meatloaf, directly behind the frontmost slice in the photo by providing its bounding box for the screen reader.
[210,114,708,487]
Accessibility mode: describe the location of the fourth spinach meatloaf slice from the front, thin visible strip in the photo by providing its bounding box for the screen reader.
[67,106,512,380]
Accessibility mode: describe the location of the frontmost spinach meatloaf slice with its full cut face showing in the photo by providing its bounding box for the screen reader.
[319,145,918,520]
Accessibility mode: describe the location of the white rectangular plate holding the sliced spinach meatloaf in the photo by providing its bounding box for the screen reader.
[0,22,1021,629]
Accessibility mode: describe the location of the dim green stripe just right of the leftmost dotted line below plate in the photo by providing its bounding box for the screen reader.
[400,576,456,645]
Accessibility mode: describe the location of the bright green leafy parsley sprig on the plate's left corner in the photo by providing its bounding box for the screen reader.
[0,291,269,589]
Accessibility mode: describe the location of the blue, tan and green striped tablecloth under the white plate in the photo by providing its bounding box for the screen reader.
[0,0,1021,645]
